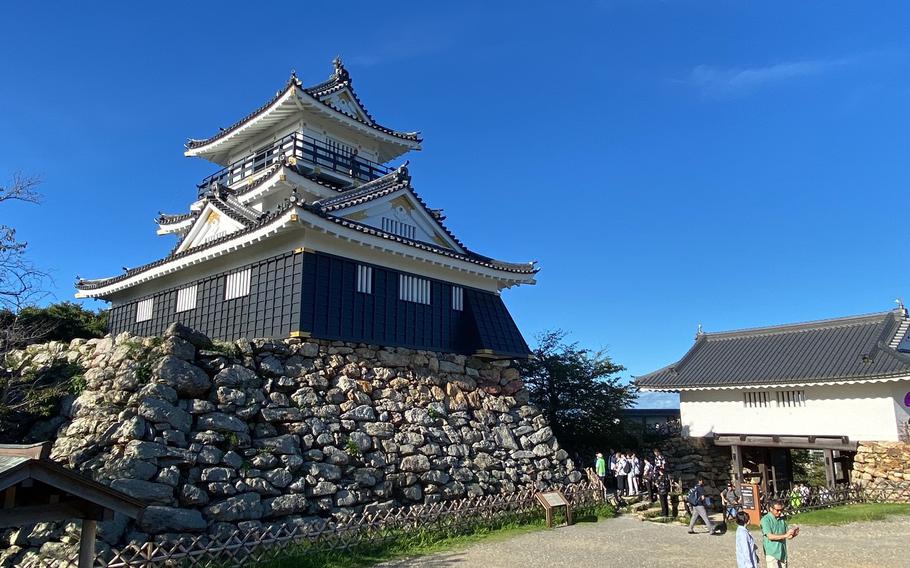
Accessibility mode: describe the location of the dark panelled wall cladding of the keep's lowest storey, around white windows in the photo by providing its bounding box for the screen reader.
[111,252,528,357]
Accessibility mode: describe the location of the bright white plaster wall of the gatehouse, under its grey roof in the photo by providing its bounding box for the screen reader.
[679,379,910,441]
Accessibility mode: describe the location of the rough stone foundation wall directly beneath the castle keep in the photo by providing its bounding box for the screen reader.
[4,326,582,564]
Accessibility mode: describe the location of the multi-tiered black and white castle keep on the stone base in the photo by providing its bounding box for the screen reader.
[76,59,537,359]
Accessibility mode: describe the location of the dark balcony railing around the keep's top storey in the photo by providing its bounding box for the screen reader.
[199,132,392,195]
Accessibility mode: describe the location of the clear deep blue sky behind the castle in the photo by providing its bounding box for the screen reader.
[0,0,910,405]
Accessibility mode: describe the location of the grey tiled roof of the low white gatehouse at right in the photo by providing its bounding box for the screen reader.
[635,308,910,390]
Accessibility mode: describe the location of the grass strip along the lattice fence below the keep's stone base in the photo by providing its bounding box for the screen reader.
[256,507,615,568]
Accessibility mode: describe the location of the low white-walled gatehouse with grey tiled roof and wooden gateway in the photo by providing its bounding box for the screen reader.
[636,306,910,485]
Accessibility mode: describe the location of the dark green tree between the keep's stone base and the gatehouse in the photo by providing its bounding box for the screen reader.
[521,330,636,453]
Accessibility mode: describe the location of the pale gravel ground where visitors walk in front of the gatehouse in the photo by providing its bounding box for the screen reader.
[379,516,910,568]
